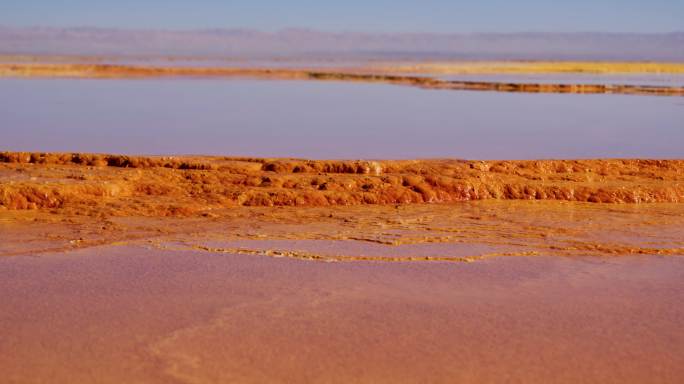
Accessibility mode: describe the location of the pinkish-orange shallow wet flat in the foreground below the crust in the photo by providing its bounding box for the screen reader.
[0,248,684,383]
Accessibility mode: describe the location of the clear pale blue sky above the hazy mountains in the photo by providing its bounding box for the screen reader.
[0,0,684,32]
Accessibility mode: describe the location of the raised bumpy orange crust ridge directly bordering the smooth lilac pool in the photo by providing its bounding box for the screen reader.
[0,152,684,216]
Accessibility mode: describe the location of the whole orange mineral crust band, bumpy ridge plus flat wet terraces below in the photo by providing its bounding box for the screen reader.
[0,153,684,261]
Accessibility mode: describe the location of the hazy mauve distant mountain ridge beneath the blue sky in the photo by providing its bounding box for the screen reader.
[0,26,684,62]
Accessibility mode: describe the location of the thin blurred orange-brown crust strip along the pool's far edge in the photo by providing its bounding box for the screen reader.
[0,63,684,96]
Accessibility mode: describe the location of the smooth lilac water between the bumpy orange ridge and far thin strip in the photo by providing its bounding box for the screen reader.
[0,79,684,159]
